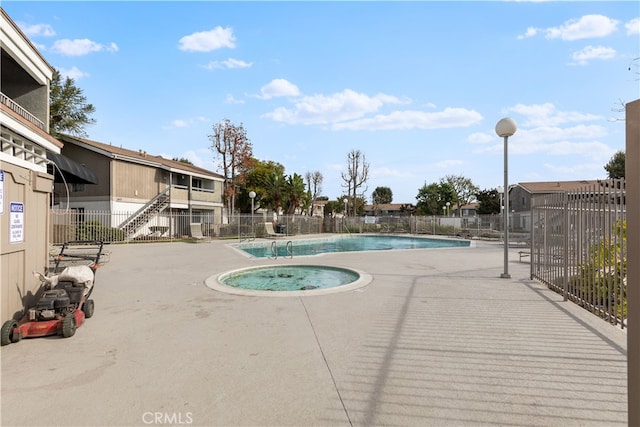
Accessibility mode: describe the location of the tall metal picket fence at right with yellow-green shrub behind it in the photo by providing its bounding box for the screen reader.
[531,180,627,328]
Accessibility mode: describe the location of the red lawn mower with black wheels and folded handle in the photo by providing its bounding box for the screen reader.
[0,240,104,345]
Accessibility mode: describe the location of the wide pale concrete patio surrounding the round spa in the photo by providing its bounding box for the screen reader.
[0,237,627,427]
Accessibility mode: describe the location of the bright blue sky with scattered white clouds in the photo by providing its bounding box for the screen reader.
[2,0,640,204]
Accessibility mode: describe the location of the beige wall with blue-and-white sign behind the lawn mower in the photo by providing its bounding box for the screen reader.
[0,162,53,322]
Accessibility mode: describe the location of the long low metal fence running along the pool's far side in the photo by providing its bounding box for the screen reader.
[51,209,531,244]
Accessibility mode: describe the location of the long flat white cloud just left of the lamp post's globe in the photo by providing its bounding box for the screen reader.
[332,108,482,130]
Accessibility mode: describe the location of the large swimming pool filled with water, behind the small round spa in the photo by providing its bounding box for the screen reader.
[236,235,471,258]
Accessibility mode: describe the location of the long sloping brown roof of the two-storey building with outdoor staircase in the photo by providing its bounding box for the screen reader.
[59,135,224,179]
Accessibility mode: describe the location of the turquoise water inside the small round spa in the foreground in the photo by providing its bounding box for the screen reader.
[218,265,360,291]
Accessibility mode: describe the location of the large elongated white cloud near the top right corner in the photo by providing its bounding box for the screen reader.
[518,15,619,41]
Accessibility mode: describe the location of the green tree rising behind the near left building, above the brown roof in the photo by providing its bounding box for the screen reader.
[49,70,96,137]
